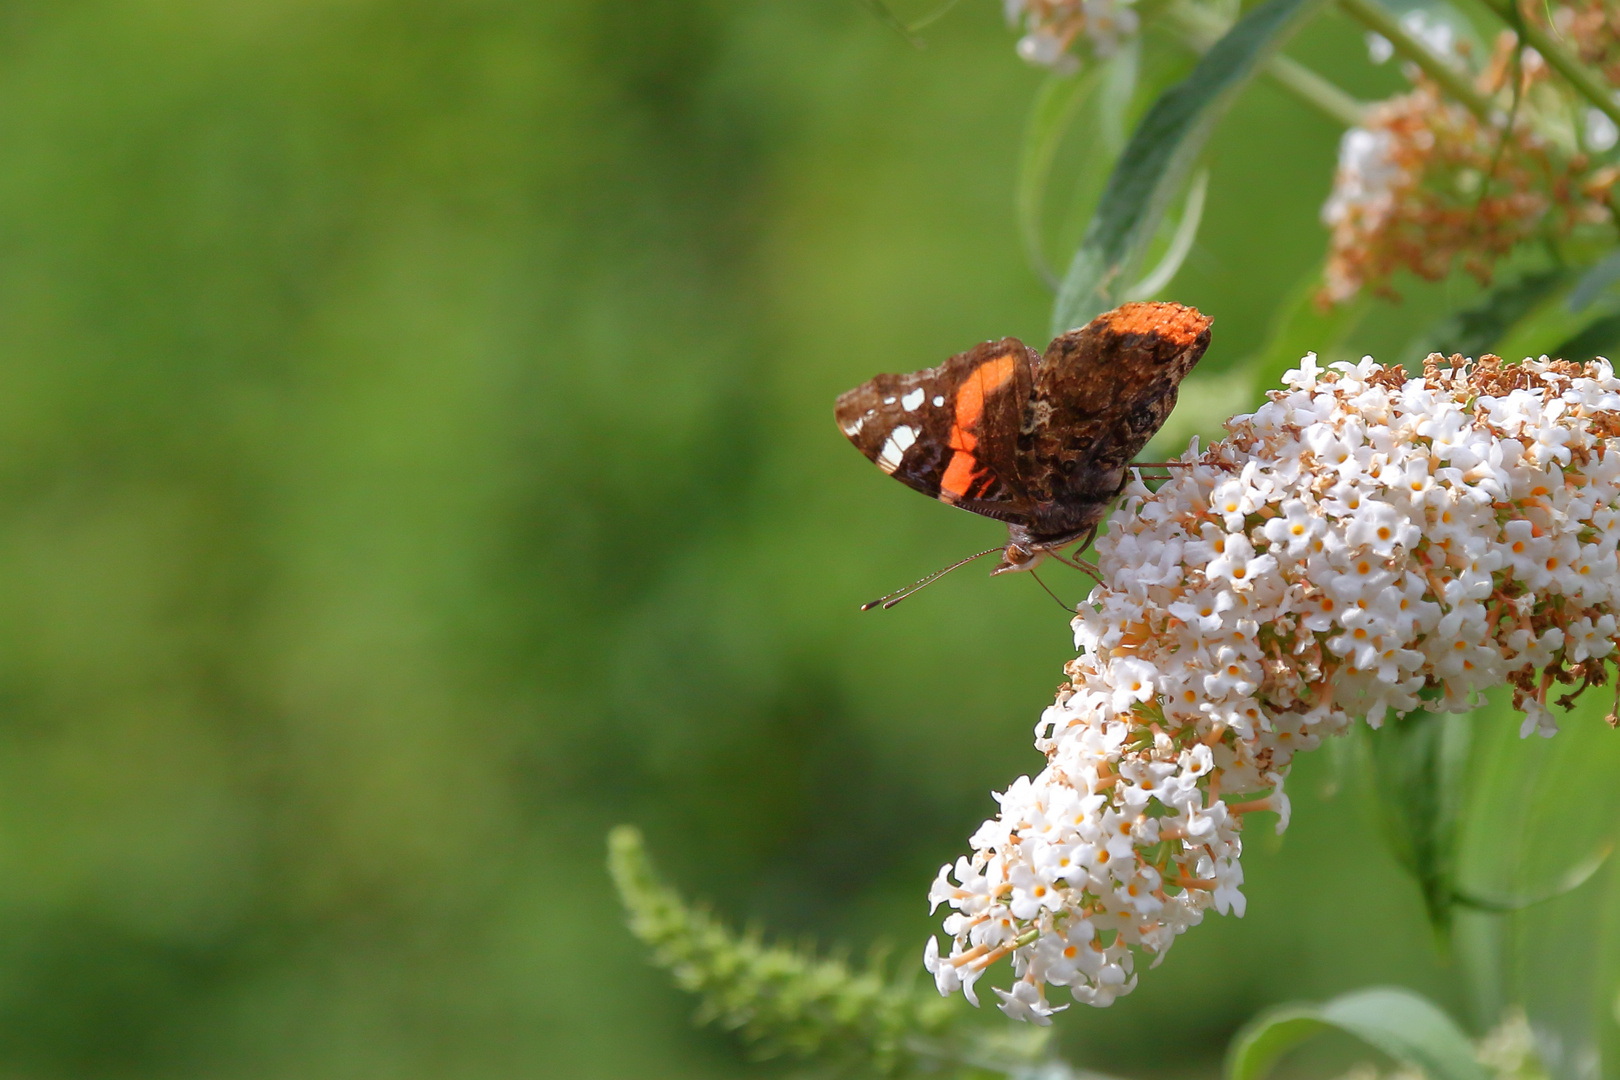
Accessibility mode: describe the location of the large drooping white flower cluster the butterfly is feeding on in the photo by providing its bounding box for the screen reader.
[927,355,1620,1023]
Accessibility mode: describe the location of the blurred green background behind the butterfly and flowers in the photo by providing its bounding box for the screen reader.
[0,0,1601,1078]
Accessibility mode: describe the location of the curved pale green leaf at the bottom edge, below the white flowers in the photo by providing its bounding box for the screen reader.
[1226,986,1486,1080]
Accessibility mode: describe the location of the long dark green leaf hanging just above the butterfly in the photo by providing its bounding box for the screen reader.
[1051,0,1324,335]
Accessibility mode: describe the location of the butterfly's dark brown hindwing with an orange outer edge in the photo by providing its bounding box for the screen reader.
[1017,303,1210,534]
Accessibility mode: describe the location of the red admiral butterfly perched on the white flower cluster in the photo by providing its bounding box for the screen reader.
[838,303,1210,607]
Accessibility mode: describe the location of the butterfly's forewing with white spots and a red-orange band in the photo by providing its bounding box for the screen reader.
[836,337,1040,523]
